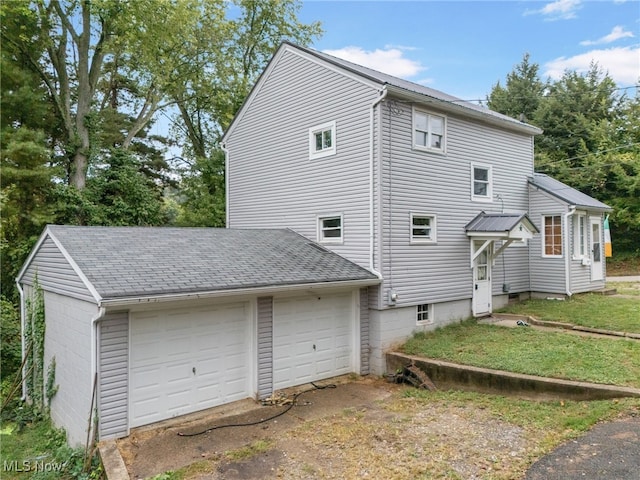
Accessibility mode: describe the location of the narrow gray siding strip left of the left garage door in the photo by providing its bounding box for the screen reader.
[98,312,129,440]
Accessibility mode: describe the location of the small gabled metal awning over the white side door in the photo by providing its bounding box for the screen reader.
[465,212,540,241]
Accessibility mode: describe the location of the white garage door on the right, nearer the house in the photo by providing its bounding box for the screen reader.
[273,293,355,390]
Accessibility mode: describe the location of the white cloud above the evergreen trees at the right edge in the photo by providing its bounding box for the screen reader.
[543,45,640,86]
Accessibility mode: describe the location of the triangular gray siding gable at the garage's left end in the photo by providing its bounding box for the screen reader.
[21,236,95,302]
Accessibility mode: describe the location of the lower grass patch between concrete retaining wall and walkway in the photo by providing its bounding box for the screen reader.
[401,321,640,388]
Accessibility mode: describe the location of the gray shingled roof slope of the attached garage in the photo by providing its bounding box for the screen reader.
[48,225,377,300]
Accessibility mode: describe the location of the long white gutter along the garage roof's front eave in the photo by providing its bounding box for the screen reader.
[96,278,380,308]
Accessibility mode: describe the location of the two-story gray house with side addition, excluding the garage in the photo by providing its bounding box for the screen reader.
[223,43,610,373]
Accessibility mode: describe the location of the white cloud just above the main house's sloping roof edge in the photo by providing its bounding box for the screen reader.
[323,46,426,79]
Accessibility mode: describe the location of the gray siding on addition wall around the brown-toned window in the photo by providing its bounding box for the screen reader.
[529,186,571,294]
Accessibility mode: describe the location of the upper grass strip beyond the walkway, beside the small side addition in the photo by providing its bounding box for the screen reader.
[500,293,640,333]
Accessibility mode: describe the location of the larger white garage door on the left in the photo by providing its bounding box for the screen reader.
[129,304,251,427]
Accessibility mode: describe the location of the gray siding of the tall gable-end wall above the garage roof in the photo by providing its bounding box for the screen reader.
[226,48,378,266]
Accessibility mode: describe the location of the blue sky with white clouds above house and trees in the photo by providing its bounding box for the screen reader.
[298,0,640,100]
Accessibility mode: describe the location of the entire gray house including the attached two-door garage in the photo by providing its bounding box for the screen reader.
[17,43,609,445]
